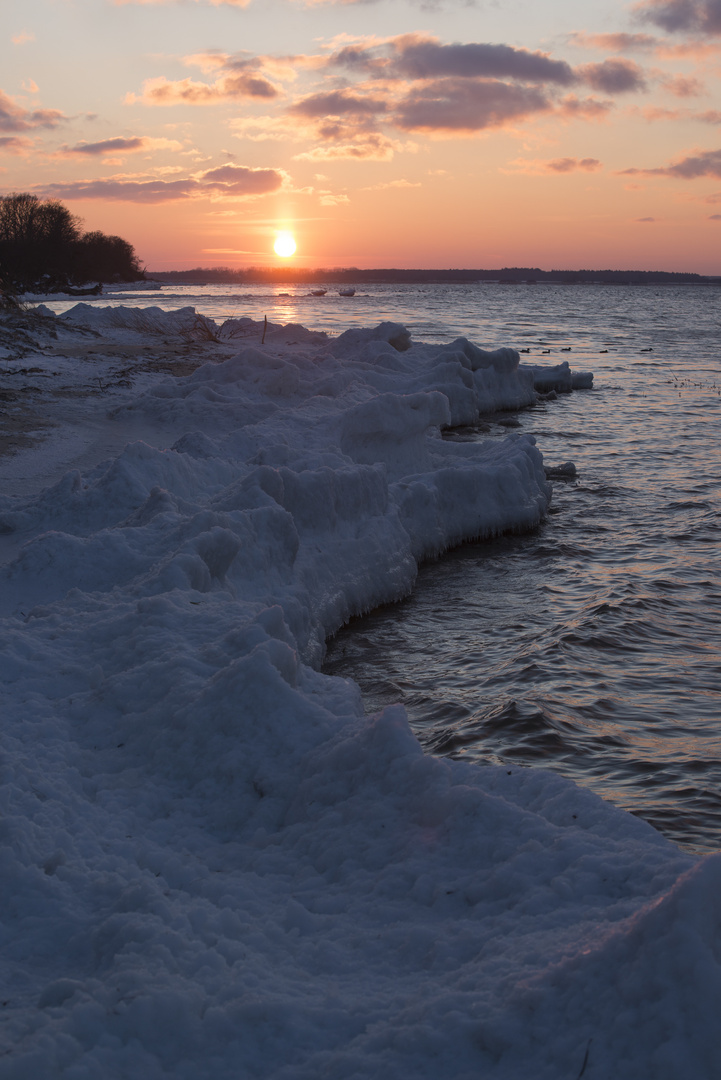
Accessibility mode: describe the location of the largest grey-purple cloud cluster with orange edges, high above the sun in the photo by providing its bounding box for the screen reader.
[113,31,669,161]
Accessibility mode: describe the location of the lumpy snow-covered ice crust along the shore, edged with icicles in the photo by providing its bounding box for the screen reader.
[0,305,721,1080]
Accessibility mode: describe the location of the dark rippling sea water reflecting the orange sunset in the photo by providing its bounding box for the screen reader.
[45,283,721,852]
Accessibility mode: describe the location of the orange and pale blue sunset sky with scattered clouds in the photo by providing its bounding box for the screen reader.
[0,0,721,274]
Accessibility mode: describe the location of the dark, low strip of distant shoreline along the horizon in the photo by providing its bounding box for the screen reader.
[146,267,721,285]
